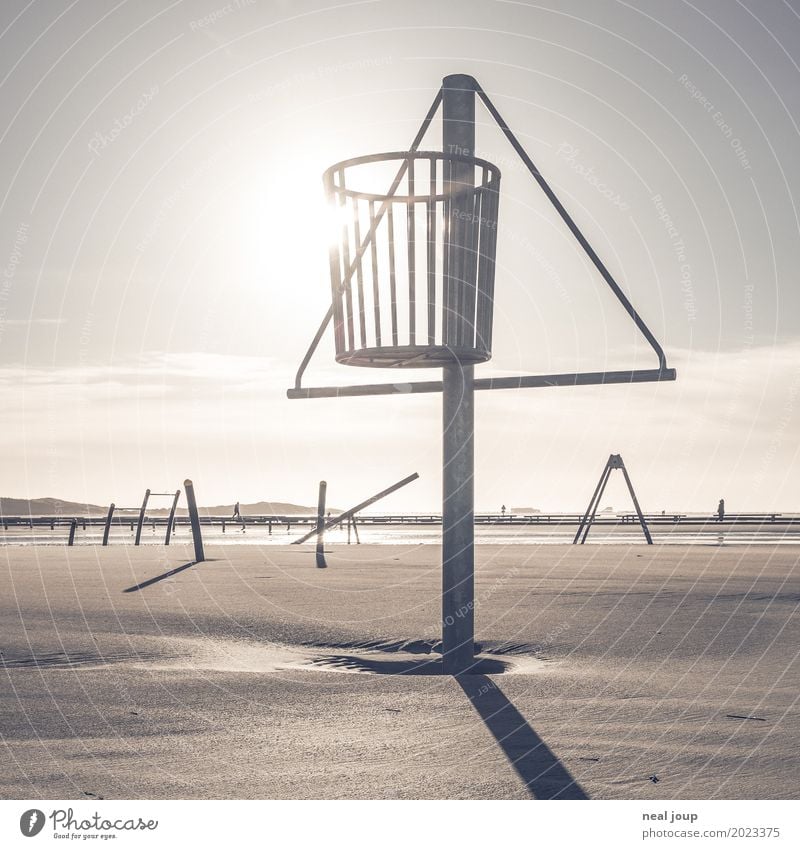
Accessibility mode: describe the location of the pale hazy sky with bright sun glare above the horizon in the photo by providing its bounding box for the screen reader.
[0,0,800,512]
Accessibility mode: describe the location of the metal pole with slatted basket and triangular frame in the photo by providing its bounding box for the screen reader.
[287,74,675,674]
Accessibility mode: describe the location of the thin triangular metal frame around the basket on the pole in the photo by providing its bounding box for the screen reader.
[286,81,676,400]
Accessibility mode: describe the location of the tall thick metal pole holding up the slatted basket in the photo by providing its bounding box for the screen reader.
[442,74,476,675]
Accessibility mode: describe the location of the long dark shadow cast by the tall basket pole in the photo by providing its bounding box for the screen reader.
[456,675,589,799]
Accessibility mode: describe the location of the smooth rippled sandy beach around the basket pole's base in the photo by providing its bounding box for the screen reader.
[0,545,800,799]
